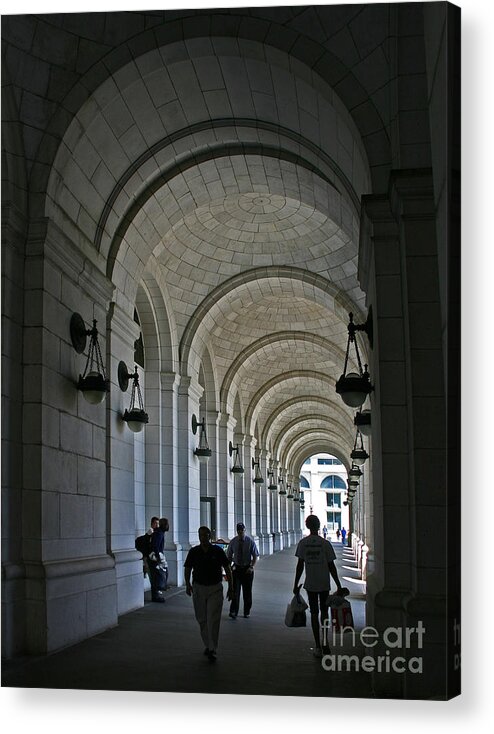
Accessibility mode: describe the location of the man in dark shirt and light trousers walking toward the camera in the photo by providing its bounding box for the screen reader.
[184,525,233,661]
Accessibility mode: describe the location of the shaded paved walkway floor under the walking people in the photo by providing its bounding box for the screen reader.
[2,542,372,698]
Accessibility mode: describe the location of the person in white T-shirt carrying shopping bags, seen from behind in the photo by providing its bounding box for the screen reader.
[293,515,342,658]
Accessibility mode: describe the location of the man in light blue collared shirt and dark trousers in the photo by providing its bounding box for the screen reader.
[226,522,259,619]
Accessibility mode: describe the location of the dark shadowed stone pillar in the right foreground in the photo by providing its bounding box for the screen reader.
[361,170,456,698]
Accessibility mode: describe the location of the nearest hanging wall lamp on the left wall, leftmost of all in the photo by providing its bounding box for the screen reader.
[70,313,110,405]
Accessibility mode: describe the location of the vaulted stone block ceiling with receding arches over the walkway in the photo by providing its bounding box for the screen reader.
[48,30,369,478]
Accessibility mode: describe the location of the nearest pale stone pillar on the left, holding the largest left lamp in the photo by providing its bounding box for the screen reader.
[15,220,116,654]
